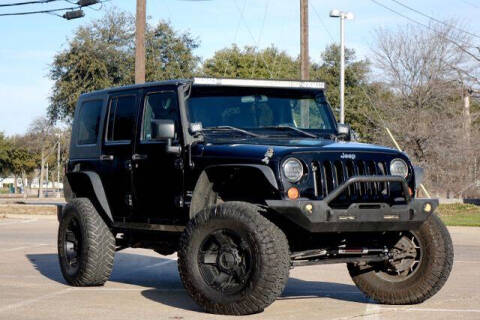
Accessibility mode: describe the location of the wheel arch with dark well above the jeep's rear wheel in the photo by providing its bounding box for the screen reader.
[64,171,113,225]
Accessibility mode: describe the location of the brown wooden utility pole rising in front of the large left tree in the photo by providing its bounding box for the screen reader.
[135,0,147,83]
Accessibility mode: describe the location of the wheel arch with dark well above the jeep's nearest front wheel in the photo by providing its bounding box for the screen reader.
[189,164,278,219]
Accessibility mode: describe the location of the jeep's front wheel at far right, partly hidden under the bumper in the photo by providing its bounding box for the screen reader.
[347,215,453,304]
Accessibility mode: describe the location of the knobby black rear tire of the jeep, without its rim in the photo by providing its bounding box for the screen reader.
[58,198,115,287]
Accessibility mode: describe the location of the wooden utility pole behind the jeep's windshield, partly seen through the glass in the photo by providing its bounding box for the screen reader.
[300,0,310,128]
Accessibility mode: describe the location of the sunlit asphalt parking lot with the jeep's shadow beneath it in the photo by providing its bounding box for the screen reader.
[0,217,480,320]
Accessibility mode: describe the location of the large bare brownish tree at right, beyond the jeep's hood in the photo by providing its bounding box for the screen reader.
[373,24,480,195]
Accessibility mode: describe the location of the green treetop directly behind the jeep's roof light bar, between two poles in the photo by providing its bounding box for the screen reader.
[201,45,300,79]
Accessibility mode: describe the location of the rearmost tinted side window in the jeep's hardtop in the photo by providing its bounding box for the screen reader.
[77,100,103,145]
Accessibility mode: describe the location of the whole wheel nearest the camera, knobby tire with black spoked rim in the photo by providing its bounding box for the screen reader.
[178,202,290,315]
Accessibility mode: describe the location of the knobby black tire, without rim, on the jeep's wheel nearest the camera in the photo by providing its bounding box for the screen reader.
[178,202,290,315]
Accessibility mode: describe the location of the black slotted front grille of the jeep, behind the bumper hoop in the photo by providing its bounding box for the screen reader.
[311,159,403,207]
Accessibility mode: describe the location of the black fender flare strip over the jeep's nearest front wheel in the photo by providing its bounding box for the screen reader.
[189,163,278,218]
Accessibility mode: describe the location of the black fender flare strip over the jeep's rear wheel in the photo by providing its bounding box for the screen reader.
[64,171,113,222]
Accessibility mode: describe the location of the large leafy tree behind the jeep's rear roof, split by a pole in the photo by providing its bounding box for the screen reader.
[48,9,199,121]
